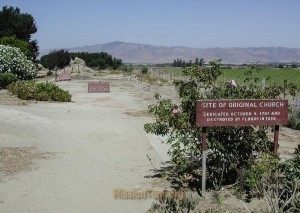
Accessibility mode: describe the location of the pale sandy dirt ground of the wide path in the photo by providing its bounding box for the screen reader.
[0,74,300,212]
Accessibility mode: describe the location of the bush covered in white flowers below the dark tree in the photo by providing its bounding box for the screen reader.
[0,45,36,80]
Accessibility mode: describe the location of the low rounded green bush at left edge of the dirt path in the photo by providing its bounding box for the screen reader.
[8,81,72,102]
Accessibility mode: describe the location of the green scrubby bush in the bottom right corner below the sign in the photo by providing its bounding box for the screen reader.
[243,151,300,212]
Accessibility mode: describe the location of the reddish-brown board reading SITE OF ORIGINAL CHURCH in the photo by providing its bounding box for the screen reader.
[196,99,288,127]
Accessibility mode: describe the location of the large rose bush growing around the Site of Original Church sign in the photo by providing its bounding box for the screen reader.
[144,61,298,189]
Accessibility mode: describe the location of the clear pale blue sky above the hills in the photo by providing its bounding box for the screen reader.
[0,0,300,50]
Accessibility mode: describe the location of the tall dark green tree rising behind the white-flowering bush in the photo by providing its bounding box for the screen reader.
[0,6,39,60]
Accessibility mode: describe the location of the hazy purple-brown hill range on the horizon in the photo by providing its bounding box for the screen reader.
[43,41,300,64]
